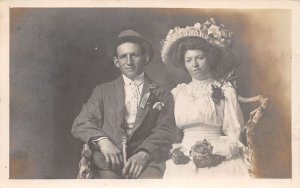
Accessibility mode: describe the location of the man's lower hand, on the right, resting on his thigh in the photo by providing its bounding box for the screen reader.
[122,151,150,178]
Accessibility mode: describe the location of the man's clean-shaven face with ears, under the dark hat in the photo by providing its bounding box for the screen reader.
[114,42,149,79]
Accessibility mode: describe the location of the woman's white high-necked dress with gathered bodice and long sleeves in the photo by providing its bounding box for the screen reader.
[164,79,250,179]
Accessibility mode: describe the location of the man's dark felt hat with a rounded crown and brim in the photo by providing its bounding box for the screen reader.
[108,30,154,62]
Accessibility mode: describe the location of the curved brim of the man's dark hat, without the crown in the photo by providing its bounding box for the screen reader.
[107,36,154,63]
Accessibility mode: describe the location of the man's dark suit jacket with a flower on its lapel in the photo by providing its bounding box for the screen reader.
[72,74,175,171]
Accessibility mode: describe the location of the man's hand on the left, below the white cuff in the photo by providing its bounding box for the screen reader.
[98,138,123,169]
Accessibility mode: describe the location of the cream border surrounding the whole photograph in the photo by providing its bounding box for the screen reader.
[0,0,300,188]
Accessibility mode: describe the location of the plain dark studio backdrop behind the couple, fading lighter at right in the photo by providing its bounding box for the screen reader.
[9,8,291,179]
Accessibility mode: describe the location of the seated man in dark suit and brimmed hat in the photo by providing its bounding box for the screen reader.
[72,30,175,178]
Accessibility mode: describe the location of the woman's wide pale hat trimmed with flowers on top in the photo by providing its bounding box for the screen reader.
[161,18,233,64]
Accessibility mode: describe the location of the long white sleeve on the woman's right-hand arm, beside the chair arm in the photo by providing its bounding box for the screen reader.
[223,83,244,140]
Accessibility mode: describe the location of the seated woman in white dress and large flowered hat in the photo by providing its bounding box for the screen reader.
[161,19,249,178]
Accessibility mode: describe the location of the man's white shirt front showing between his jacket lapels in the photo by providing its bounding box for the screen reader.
[122,72,144,135]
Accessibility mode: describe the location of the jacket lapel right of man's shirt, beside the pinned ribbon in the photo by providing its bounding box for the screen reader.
[130,74,151,140]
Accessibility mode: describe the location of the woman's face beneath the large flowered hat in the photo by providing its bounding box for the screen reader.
[184,49,211,80]
